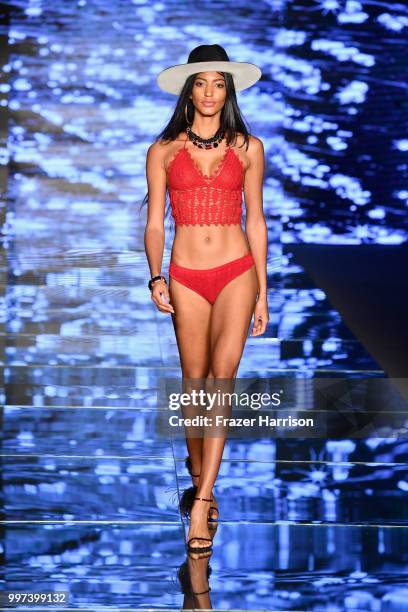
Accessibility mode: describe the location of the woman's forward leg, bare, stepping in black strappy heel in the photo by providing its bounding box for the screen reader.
[188,266,258,547]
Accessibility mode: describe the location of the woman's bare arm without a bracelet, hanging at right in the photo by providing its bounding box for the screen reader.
[244,136,269,335]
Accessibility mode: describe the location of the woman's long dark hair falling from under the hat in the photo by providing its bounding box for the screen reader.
[139,72,250,227]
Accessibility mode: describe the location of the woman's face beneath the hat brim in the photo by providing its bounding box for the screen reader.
[191,72,227,116]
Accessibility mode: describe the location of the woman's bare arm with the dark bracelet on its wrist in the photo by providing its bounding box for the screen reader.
[144,142,174,312]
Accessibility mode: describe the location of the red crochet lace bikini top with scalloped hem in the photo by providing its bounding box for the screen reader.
[167,139,244,225]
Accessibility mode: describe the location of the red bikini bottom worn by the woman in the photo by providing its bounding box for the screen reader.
[169,253,255,304]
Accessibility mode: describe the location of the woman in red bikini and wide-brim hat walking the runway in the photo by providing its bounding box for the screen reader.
[145,45,269,553]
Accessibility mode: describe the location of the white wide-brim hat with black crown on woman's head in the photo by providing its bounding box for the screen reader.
[157,45,262,95]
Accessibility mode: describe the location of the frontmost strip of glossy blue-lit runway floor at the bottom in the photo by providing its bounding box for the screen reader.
[7,524,407,610]
